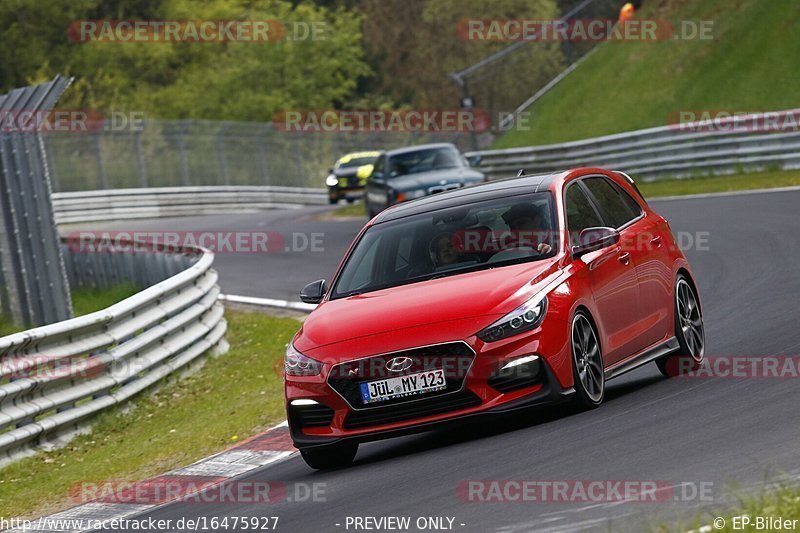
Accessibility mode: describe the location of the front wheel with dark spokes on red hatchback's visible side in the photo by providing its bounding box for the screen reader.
[570,311,606,411]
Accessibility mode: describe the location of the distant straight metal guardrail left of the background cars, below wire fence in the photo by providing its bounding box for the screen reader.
[53,185,328,224]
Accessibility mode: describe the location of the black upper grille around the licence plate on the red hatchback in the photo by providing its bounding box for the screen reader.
[328,342,475,410]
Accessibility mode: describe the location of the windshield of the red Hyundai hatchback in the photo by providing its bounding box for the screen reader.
[331,192,558,299]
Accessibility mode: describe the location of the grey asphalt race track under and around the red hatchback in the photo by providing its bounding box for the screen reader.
[89,191,800,532]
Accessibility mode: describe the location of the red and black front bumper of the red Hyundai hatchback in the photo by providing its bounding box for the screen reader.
[286,330,574,448]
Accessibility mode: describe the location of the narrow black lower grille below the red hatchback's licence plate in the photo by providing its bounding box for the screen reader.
[344,391,481,429]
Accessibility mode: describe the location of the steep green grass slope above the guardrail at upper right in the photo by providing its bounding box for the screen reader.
[494,0,800,148]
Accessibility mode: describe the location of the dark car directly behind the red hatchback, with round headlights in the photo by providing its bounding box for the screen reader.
[364,143,486,218]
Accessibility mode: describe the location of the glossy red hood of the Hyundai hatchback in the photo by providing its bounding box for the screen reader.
[295,259,558,352]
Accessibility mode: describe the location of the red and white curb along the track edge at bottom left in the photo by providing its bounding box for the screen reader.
[7,421,297,533]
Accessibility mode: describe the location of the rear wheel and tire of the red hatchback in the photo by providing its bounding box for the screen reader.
[656,274,706,378]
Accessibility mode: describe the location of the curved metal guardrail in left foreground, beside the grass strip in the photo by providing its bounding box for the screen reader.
[0,235,227,463]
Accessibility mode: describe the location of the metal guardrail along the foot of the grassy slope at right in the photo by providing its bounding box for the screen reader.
[467,110,800,181]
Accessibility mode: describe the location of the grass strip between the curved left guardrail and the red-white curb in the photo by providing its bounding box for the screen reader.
[0,311,299,517]
